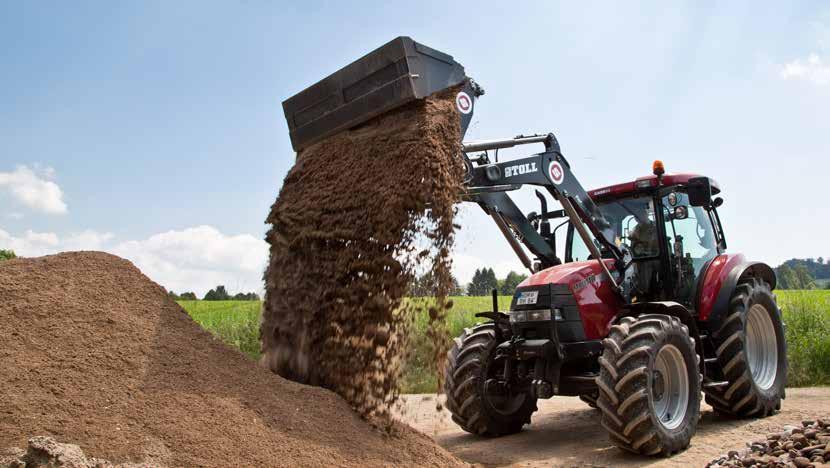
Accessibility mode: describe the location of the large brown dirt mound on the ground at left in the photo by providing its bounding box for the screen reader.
[0,252,457,466]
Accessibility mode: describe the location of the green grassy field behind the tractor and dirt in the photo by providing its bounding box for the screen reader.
[179,290,830,393]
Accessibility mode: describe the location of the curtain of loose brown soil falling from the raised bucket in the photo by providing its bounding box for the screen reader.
[260,90,464,417]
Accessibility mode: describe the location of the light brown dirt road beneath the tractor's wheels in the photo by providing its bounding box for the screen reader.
[401,388,830,467]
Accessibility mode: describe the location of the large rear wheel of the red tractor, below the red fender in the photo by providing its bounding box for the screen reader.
[706,278,787,417]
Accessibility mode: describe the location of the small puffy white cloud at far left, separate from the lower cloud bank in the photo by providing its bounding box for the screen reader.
[0,166,67,214]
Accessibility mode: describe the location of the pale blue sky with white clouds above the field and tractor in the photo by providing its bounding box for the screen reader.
[0,0,830,295]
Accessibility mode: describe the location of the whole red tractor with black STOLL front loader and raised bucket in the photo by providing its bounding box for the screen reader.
[283,37,787,455]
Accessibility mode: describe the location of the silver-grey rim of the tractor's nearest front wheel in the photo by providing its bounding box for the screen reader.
[651,345,689,429]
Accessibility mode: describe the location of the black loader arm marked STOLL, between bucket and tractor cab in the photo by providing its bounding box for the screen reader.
[463,133,624,291]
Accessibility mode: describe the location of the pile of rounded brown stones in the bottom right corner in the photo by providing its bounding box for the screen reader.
[707,419,830,468]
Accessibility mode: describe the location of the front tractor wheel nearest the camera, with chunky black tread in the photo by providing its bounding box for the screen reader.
[597,314,702,456]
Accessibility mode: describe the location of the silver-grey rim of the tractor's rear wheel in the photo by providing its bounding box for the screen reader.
[745,304,778,390]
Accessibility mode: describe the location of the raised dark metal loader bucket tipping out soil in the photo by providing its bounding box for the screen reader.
[282,36,472,151]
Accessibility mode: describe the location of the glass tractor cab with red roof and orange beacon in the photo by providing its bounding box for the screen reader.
[564,166,726,310]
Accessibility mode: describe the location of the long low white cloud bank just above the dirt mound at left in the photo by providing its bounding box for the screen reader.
[0,226,268,296]
